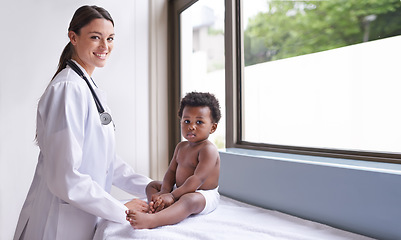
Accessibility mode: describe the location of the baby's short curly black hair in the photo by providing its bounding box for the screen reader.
[178,92,221,123]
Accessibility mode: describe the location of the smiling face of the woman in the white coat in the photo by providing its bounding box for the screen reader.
[68,18,114,76]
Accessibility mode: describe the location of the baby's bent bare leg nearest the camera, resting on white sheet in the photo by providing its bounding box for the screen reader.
[127,193,206,229]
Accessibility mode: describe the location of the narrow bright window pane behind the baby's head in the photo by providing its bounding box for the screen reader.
[180,0,225,149]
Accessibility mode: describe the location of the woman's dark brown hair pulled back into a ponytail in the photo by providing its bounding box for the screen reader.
[52,5,114,79]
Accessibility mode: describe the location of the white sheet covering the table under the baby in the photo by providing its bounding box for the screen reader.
[94,196,371,240]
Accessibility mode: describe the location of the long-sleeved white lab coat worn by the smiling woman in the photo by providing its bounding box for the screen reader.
[14,61,151,240]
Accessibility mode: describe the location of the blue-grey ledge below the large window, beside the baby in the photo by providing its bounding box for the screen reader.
[219,148,401,239]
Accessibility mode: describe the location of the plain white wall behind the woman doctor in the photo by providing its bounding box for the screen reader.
[0,0,150,239]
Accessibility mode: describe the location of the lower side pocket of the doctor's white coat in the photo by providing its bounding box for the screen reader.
[56,203,97,240]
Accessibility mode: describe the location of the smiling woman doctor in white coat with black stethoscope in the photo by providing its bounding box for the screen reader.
[14,6,151,240]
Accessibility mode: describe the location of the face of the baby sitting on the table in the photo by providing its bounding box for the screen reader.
[181,106,217,143]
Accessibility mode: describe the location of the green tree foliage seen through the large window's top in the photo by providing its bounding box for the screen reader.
[243,0,401,66]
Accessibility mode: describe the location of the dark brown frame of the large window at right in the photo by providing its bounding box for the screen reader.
[225,0,401,164]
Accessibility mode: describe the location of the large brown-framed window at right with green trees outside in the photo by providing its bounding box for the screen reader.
[226,0,401,162]
